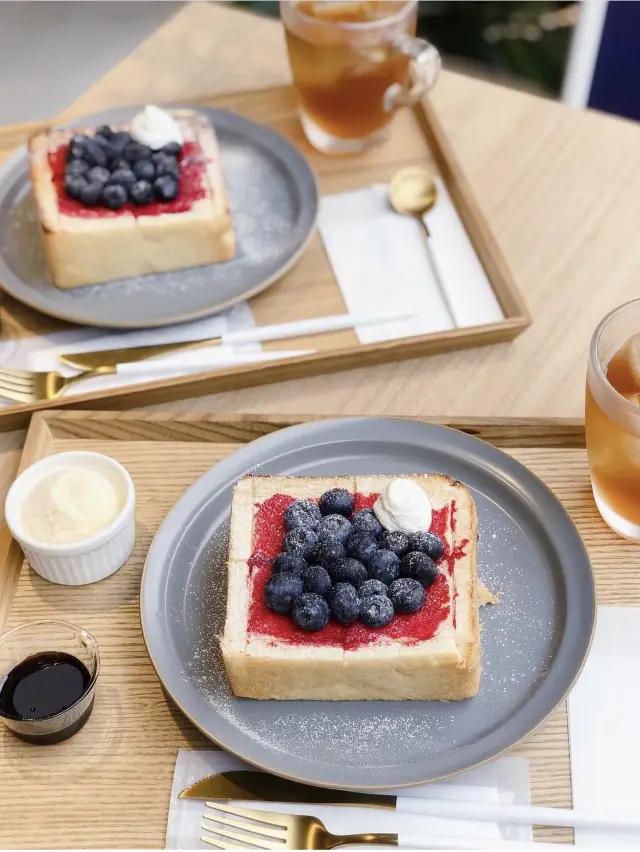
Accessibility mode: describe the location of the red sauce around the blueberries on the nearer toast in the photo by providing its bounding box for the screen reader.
[249,494,468,650]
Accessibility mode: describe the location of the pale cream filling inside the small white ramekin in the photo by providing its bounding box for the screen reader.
[22,467,123,544]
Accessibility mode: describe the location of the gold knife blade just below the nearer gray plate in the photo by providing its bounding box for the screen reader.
[180,769,396,810]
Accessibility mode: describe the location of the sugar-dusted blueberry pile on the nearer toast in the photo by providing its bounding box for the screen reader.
[264,488,444,631]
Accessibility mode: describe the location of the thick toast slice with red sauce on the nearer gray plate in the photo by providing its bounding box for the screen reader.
[221,474,480,700]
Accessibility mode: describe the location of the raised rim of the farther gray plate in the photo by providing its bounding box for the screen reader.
[0,101,320,330]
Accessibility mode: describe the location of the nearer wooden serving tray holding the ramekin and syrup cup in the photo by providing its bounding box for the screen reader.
[0,411,640,848]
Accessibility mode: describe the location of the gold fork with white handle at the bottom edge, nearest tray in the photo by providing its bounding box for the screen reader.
[201,802,560,850]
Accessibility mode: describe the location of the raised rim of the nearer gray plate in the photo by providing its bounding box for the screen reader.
[138,415,597,792]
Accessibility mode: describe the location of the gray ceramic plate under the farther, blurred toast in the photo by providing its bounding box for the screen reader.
[0,107,318,328]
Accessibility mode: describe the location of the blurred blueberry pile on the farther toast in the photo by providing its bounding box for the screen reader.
[64,125,182,210]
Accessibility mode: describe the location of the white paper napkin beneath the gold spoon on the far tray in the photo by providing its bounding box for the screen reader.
[319,178,504,343]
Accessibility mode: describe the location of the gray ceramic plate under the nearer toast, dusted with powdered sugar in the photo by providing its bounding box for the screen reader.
[141,418,595,789]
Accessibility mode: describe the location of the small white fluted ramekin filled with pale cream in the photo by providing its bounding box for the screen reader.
[5,451,135,586]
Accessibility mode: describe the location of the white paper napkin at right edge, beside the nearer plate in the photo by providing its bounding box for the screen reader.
[568,606,640,849]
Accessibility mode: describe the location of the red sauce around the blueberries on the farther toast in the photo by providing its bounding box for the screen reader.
[49,142,207,219]
